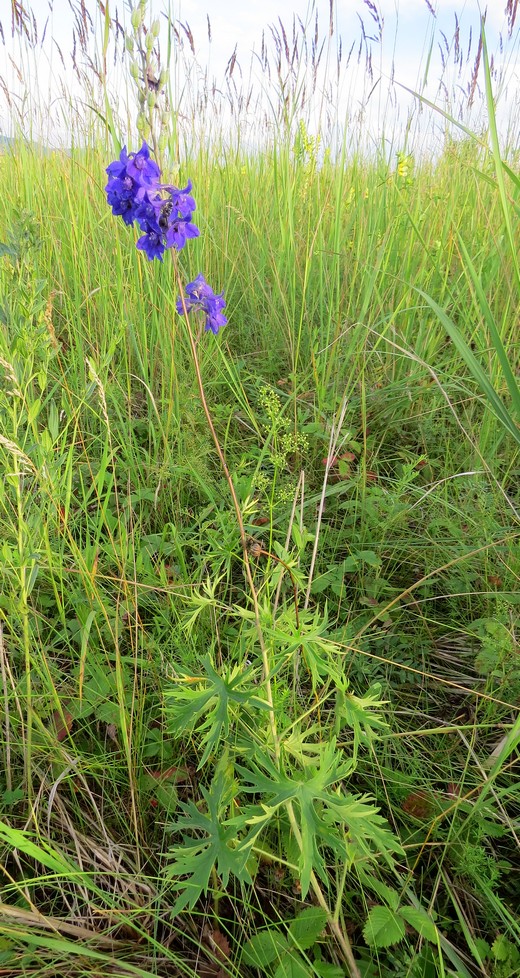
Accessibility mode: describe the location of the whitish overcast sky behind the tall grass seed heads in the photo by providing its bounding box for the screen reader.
[0,0,520,150]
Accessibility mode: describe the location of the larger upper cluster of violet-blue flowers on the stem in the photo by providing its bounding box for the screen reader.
[105,142,199,261]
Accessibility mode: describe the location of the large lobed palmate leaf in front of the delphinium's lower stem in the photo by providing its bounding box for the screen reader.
[237,740,402,897]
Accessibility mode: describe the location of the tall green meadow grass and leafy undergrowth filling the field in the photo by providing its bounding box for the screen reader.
[0,3,520,978]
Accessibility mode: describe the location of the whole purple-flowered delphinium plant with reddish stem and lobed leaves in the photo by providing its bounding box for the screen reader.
[101,9,418,978]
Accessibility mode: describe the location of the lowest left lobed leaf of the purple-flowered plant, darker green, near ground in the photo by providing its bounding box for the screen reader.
[165,767,251,914]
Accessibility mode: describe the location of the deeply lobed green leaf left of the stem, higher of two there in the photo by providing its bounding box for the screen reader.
[166,655,270,769]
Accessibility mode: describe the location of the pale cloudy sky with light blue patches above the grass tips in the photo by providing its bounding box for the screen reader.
[0,0,520,151]
